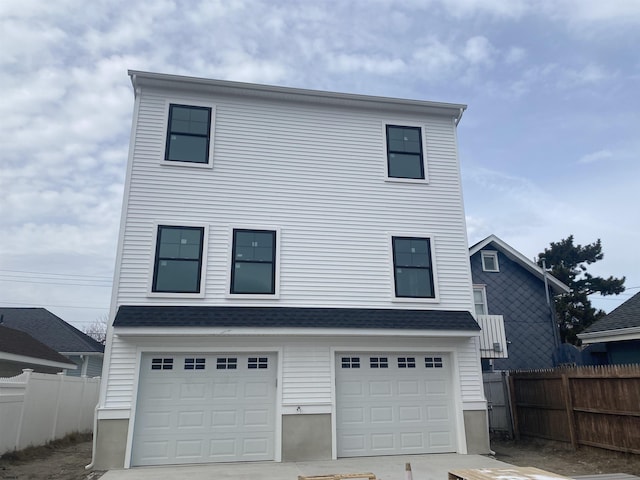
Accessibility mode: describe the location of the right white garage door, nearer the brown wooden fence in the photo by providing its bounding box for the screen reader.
[336,352,456,457]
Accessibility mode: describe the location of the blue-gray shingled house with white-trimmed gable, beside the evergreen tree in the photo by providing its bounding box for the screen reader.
[469,235,569,370]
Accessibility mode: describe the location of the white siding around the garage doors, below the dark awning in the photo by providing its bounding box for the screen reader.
[103,336,483,409]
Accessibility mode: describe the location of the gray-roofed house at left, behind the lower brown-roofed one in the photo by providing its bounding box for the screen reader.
[0,308,104,377]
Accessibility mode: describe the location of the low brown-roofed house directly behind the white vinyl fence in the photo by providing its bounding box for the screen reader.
[0,325,77,377]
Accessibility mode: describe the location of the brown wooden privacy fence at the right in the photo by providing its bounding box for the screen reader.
[509,365,640,454]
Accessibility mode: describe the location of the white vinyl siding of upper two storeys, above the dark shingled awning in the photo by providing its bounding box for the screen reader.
[117,92,472,310]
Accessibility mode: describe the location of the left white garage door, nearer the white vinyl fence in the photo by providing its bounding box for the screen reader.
[131,353,276,465]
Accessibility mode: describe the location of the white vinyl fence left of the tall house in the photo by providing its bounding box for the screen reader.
[0,369,100,454]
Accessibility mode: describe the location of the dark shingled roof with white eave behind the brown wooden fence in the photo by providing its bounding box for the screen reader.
[578,292,640,343]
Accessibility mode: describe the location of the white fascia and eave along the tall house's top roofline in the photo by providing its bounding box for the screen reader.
[128,70,467,122]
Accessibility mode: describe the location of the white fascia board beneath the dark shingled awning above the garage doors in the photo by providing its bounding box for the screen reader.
[114,327,480,338]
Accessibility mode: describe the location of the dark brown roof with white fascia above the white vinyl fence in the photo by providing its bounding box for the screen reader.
[0,325,77,369]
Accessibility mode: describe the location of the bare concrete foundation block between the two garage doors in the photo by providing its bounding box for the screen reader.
[282,414,331,462]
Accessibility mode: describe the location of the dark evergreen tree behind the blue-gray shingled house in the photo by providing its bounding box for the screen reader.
[538,235,625,345]
